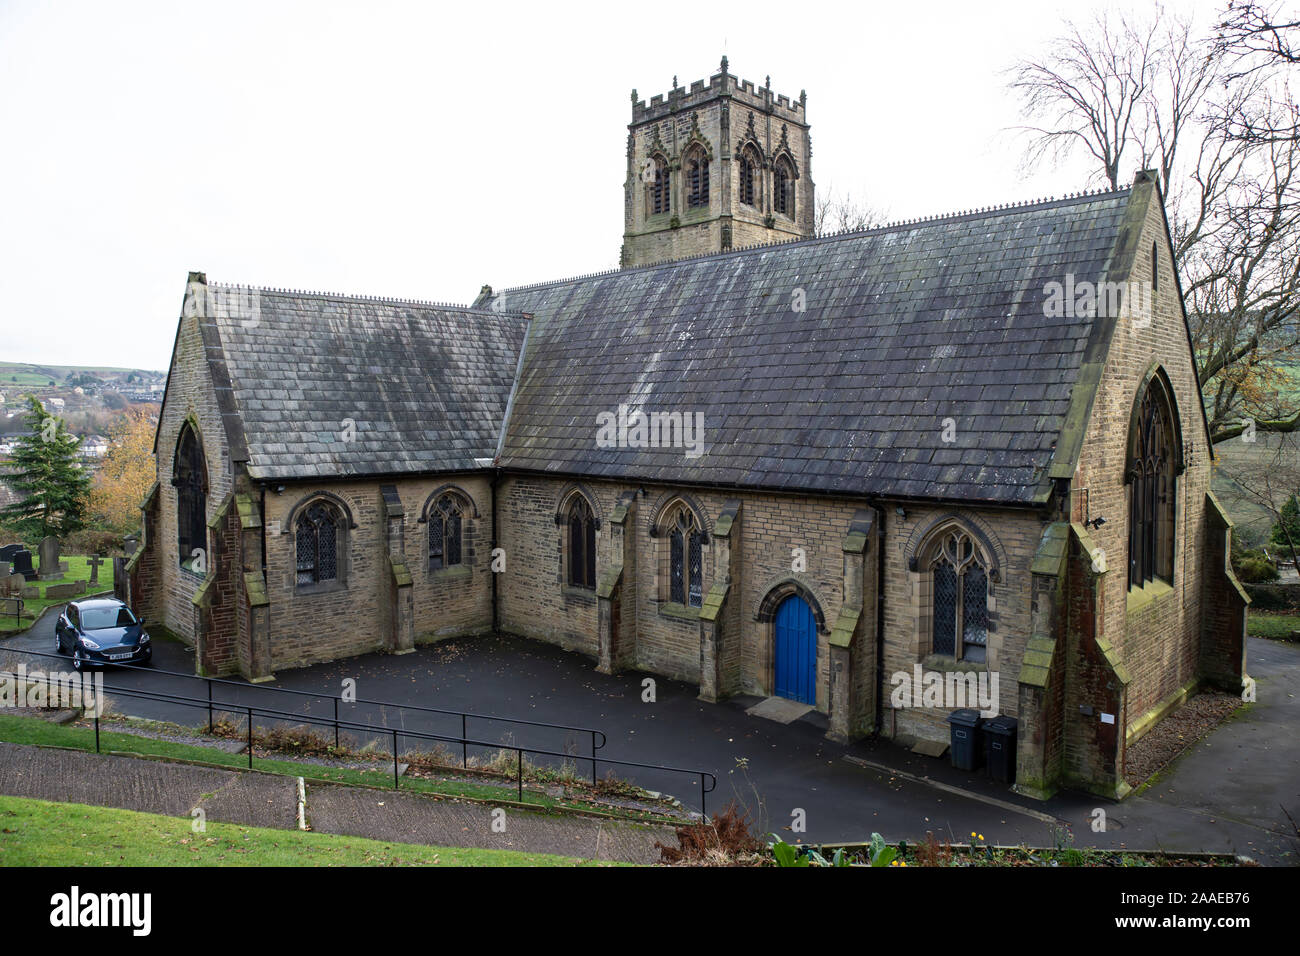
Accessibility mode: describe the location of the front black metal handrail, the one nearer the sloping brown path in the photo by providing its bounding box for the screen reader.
[0,665,718,816]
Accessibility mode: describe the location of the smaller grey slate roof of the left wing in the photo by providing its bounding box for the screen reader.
[200,284,528,480]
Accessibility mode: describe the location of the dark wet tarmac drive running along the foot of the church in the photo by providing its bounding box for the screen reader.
[0,618,1300,865]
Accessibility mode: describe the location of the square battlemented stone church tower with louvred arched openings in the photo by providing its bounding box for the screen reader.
[620,56,813,268]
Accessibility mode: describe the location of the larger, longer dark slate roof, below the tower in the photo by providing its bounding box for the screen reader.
[488,189,1130,505]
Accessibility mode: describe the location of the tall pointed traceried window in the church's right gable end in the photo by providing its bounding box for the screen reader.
[1128,375,1175,588]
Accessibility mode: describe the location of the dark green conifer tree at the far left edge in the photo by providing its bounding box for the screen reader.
[0,395,90,538]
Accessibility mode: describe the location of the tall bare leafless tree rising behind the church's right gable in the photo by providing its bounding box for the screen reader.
[1010,7,1300,442]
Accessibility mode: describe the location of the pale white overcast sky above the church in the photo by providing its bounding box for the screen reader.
[0,0,1219,369]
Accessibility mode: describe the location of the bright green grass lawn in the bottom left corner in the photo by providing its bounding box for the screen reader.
[0,796,602,866]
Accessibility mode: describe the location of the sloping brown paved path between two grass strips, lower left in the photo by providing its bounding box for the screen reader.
[0,743,676,864]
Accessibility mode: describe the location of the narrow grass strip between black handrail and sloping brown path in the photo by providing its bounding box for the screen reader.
[0,714,686,821]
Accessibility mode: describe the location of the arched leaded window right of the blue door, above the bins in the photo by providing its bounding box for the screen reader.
[930,528,988,661]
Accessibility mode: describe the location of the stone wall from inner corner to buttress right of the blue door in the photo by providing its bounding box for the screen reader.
[498,475,875,711]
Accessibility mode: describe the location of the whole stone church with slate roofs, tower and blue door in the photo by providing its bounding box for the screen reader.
[120,60,1247,796]
